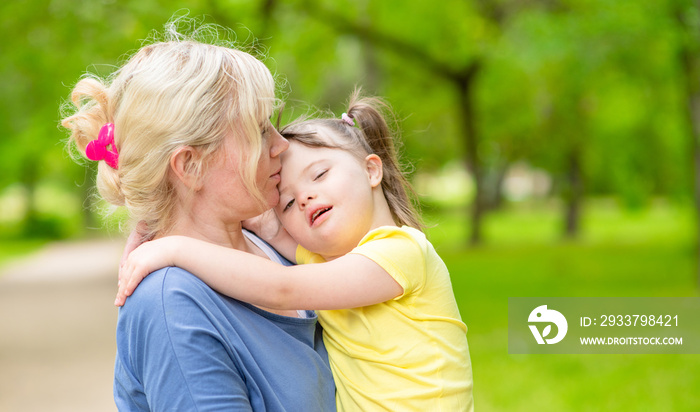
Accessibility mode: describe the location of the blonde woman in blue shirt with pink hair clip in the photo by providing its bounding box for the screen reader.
[63,23,335,411]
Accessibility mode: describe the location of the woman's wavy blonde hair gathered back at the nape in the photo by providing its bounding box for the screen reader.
[62,21,276,236]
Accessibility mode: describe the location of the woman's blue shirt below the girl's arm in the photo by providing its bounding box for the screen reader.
[114,233,335,412]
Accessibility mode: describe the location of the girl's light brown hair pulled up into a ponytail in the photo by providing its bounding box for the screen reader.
[280,89,424,230]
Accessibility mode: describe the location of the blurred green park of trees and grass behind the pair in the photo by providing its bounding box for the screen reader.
[0,0,700,411]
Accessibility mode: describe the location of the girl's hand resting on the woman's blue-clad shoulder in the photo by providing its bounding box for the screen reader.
[114,236,178,306]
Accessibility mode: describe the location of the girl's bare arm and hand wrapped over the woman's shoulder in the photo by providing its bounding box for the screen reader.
[115,236,403,309]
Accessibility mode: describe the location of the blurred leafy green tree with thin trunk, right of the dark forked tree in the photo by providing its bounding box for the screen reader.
[490,0,685,237]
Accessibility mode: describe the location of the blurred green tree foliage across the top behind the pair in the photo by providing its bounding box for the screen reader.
[0,0,700,240]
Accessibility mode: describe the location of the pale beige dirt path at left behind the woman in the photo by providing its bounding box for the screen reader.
[0,239,123,412]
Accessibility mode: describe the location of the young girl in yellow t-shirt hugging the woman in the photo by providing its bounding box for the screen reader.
[115,92,473,411]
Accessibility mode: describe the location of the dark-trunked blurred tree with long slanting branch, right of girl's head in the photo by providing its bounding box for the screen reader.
[268,1,500,243]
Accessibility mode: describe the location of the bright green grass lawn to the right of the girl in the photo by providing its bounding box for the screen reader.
[427,202,700,411]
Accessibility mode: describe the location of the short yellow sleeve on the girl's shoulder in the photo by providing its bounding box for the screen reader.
[350,226,426,300]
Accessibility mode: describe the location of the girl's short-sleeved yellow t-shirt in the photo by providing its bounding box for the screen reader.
[297,226,473,412]
